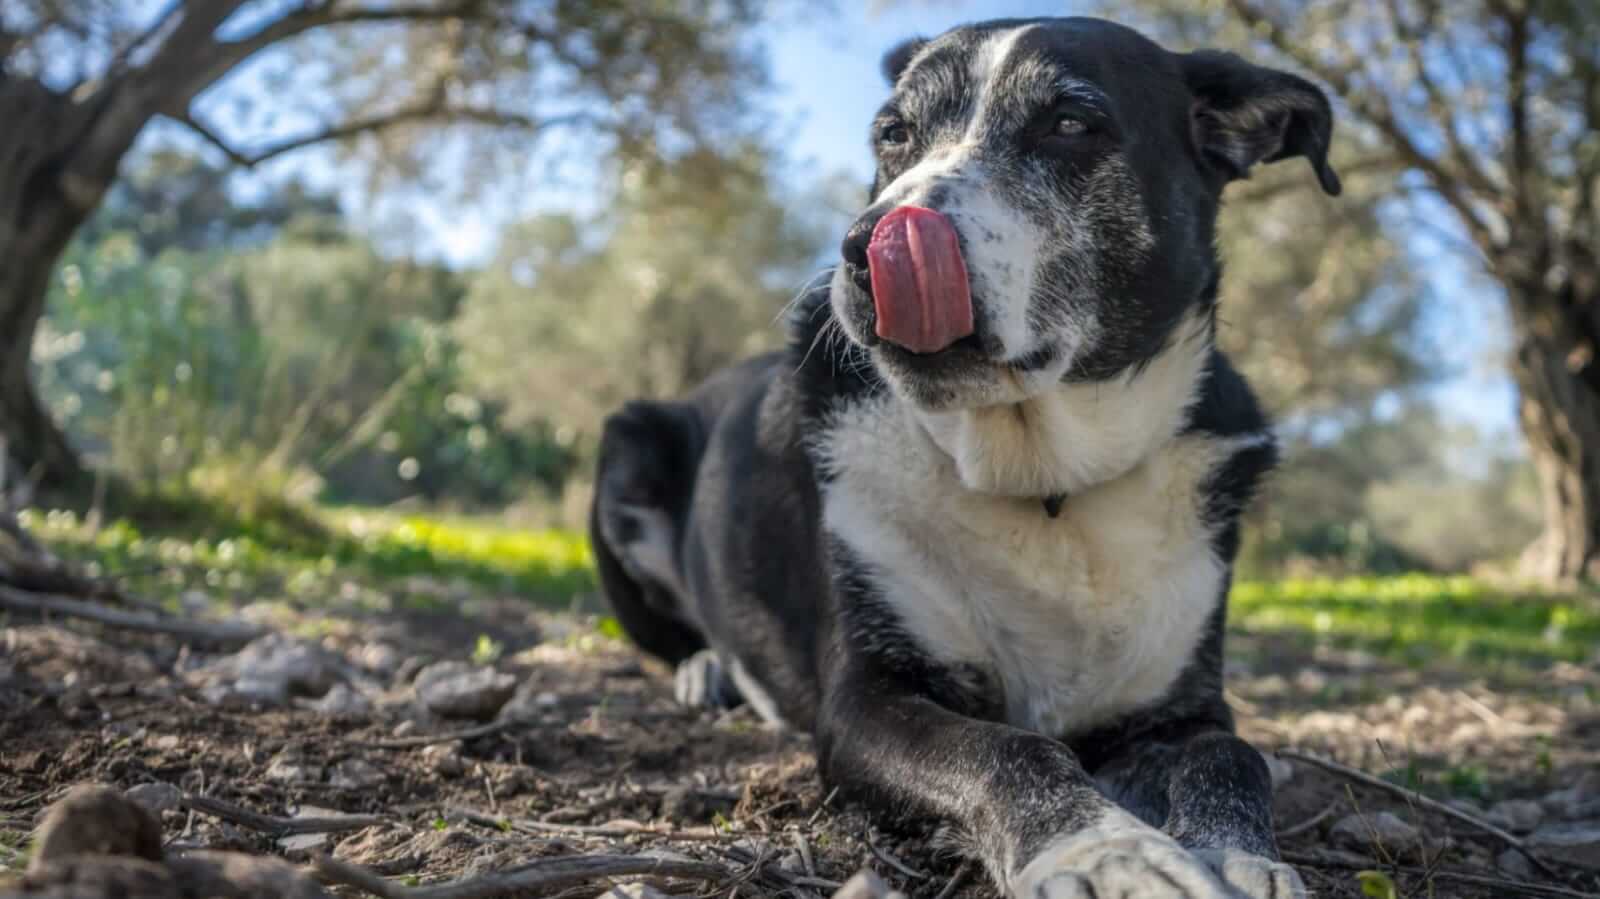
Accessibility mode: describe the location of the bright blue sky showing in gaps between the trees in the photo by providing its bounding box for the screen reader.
[165,0,1515,442]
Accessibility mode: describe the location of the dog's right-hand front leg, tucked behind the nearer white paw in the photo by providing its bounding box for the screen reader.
[1094,731,1306,899]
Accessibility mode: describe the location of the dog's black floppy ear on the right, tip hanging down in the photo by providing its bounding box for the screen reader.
[1179,50,1341,197]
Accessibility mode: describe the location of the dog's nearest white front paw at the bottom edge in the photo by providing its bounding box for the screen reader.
[1010,813,1238,899]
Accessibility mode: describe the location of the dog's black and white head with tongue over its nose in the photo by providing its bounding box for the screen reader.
[832,18,1339,410]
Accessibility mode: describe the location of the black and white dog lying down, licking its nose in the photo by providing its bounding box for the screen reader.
[592,19,1339,899]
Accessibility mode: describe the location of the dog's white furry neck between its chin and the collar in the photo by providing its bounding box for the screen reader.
[910,317,1211,495]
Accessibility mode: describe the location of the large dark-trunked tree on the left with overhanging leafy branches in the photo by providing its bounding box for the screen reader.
[0,0,780,483]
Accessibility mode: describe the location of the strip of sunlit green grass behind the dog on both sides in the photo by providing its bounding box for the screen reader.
[26,494,1600,664]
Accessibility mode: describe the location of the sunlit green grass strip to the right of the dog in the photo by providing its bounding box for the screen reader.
[1229,574,1600,662]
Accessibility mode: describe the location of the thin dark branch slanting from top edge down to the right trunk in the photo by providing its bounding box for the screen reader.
[1227,0,1498,253]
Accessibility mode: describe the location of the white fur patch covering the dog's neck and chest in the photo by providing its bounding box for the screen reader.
[818,321,1267,736]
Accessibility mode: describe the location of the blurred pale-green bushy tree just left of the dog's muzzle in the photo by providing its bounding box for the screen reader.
[456,146,843,442]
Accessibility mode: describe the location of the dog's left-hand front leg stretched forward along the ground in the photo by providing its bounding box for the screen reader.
[818,675,1237,899]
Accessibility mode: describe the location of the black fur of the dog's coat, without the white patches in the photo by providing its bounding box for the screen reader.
[592,19,1338,899]
